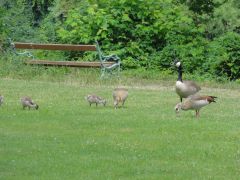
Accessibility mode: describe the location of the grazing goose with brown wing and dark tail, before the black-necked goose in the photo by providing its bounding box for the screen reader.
[175,95,217,117]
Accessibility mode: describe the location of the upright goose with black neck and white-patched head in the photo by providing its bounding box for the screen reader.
[174,60,201,102]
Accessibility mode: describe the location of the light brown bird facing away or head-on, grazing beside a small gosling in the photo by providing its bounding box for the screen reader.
[113,88,128,109]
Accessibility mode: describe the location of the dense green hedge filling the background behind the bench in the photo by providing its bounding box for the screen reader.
[0,0,240,80]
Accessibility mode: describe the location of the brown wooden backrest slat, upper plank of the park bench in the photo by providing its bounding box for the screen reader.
[14,42,96,51]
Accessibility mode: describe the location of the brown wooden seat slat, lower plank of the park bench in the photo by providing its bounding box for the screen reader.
[25,60,115,68]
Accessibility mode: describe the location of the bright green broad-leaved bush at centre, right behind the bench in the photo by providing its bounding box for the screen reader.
[58,0,202,68]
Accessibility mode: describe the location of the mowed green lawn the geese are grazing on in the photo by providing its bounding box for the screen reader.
[0,79,240,180]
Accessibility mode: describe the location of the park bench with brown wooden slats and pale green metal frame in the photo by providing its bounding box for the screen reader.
[10,41,121,77]
